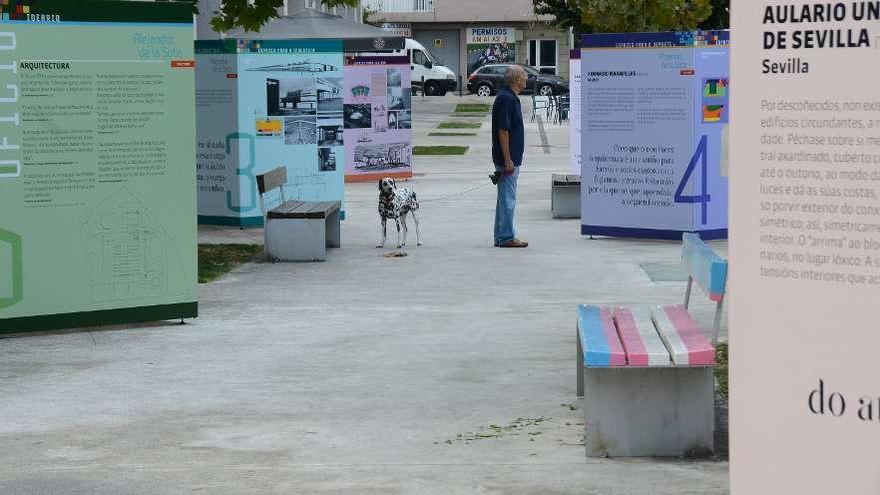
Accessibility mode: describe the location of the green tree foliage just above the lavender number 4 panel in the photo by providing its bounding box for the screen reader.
[580,0,713,33]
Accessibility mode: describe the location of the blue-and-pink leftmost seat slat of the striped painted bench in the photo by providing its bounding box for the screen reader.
[578,305,626,366]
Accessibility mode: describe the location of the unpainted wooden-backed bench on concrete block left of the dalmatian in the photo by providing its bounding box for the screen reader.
[257,167,341,261]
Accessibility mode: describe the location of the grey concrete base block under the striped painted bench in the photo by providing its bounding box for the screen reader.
[583,366,715,457]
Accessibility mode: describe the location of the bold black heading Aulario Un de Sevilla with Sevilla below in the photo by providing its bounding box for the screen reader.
[761,1,880,74]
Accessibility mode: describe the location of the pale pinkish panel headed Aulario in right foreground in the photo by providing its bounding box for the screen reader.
[730,0,880,495]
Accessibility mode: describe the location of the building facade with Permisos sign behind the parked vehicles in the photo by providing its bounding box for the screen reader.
[362,0,571,80]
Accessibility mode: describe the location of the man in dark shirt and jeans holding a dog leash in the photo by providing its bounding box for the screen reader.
[492,65,529,248]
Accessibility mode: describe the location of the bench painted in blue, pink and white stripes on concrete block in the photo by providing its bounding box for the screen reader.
[577,234,727,457]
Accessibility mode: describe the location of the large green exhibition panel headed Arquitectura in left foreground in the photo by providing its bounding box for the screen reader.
[0,0,197,333]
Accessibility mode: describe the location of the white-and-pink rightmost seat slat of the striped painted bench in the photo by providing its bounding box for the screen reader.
[651,306,715,366]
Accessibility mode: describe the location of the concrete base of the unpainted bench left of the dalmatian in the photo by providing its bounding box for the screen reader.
[265,210,340,261]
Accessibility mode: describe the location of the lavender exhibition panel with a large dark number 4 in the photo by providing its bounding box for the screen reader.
[581,31,730,239]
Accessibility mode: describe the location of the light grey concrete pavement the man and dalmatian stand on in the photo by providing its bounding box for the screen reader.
[0,96,729,495]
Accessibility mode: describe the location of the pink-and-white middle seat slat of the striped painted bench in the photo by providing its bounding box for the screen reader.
[614,308,670,366]
